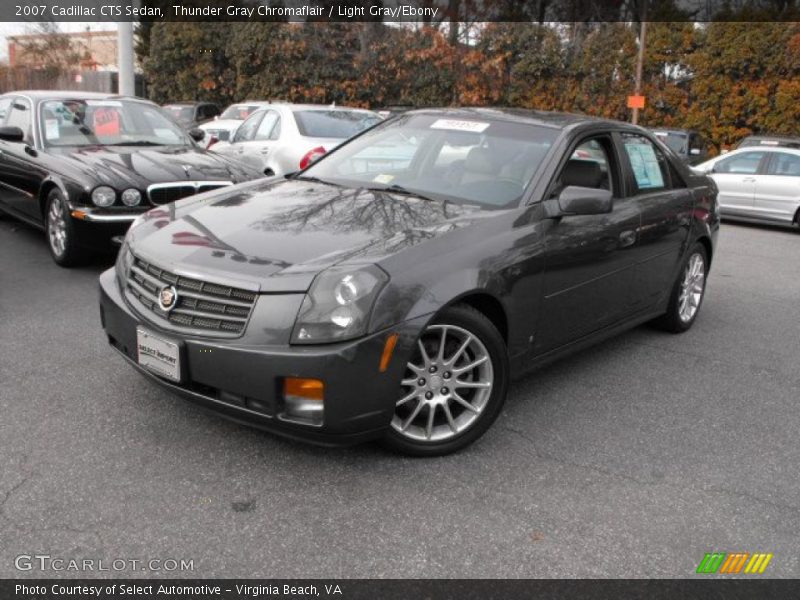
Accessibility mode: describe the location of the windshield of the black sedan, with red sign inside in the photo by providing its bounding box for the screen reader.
[40,99,189,146]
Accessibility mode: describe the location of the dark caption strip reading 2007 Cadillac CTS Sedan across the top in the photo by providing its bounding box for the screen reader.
[0,0,800,24]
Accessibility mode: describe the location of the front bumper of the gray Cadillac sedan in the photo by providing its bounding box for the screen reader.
[100,269,428,446]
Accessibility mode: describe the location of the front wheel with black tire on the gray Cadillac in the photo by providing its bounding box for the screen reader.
[385,305,509,456]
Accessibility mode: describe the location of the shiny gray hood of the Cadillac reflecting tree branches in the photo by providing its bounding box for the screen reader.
[128,180,493,292]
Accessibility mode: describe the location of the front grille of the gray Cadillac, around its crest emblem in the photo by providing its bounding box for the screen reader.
[127,257,256,334]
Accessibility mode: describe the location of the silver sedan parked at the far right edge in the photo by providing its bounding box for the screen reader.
[695,146,800,225]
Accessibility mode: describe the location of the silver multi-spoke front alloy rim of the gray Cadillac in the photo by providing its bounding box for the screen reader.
[392,323,494,442]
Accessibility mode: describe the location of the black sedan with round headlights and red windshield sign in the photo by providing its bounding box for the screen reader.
[0,91,262,266]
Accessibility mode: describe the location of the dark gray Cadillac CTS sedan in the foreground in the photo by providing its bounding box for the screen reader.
[100,109,719,455]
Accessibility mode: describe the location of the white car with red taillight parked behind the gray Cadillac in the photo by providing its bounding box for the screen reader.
[214,103,381,176]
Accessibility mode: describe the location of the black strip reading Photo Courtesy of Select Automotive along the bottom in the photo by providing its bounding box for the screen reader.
[0,579,800,600]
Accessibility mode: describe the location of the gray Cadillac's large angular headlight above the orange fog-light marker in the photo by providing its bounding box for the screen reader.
[292,265,389,344]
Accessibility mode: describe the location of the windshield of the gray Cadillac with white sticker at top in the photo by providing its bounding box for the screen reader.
[301,115,559,208]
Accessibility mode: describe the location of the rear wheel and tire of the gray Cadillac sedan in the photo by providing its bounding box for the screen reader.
[653,243,708,333]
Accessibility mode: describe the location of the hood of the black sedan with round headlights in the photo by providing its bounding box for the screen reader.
[48,146,253,189]
